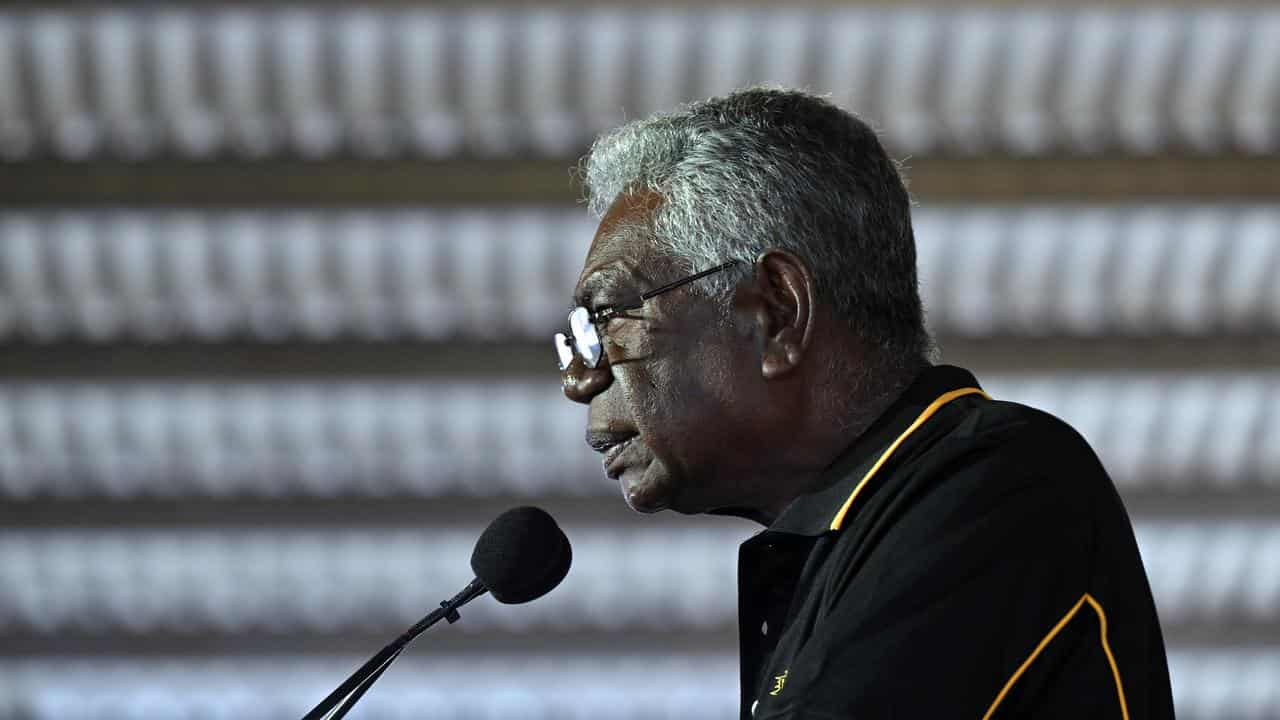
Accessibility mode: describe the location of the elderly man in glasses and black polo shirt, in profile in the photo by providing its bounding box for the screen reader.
[556,90,1172,720]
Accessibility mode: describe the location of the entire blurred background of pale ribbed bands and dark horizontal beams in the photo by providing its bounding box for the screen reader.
[0,0,1280,720]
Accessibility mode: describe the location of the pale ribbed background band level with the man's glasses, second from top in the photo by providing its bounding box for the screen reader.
[0,204,1280,342]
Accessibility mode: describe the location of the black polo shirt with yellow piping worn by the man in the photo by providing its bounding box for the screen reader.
[739,365,1174,720]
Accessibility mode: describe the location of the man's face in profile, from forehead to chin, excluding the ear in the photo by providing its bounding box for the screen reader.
[562,193,750,512]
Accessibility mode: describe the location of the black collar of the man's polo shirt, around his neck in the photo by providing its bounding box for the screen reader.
[768,365,979,536]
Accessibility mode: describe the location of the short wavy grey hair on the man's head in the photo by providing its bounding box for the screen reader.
[582,87,933,369]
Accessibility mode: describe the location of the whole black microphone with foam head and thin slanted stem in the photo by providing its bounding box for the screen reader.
[302,506,573,720]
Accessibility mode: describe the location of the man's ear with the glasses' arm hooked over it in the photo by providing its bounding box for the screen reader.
[742,249,814,379]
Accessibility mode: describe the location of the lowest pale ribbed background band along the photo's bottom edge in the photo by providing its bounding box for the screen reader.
[0,650,1280,720]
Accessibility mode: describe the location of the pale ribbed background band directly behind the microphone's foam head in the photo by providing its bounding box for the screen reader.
[0,519,1280,630]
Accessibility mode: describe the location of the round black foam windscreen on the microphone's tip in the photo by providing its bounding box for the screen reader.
[471,506,573,605]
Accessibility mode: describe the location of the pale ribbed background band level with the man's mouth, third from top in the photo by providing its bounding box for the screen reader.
[0,372,1280,500]
